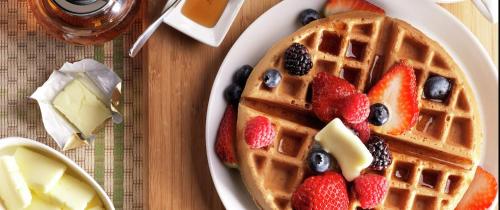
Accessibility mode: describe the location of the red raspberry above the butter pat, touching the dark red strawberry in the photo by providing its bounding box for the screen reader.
[334,93,370,124]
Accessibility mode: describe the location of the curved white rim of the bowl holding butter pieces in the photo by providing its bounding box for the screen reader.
[0,137,115,210]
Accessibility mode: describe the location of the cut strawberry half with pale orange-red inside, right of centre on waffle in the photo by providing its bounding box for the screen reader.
[368,60,419,135]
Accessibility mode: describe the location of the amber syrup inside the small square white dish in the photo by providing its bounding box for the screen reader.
[182,0,228,28]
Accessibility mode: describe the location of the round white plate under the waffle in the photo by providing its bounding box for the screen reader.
[206,0,498,209]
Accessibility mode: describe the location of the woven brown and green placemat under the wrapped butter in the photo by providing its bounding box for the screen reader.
[0,0,144,209]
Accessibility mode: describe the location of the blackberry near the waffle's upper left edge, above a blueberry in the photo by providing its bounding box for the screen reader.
[285,43,313,76]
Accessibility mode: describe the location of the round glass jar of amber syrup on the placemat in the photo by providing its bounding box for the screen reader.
[28,0,142,45]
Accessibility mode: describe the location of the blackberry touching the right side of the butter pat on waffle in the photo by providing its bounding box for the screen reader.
[366,136,392,171]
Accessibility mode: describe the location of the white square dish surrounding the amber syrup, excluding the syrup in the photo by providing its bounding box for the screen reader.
[163,0,244,47]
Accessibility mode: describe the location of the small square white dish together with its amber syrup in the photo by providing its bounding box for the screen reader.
[164,0,244,47]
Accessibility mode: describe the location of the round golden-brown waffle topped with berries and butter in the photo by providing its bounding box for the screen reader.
[236,11,482,210]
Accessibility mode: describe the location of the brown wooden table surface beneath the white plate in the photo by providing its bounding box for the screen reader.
[143,0,498,210]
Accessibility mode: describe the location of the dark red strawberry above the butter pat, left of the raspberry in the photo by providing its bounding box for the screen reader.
[312,72,356,122]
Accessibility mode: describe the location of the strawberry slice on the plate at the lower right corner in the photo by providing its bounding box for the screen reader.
[455,167,498,210]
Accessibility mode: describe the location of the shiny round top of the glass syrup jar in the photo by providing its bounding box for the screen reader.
[52,0,112,16]
